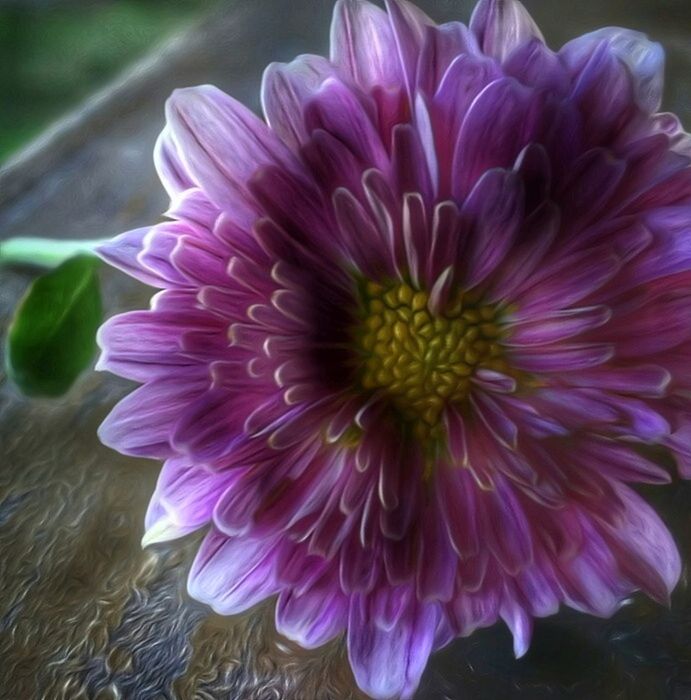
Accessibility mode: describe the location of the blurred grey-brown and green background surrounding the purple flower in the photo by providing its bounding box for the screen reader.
[0,0,691,700]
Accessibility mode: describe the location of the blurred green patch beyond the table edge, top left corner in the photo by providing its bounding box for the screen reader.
[0,0,218,163]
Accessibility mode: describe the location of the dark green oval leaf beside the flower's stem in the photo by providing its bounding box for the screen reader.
[5,255,103,396]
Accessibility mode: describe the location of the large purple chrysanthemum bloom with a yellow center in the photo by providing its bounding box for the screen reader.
[100,0,691,698]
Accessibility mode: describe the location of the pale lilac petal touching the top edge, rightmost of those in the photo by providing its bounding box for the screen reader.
[470,0,544,61]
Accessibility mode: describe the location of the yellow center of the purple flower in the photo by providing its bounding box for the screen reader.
[355,282,507,440]
